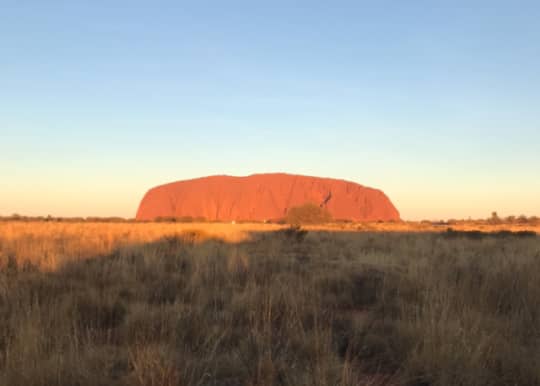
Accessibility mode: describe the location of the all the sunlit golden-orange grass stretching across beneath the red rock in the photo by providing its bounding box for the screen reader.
[0,221,540,270]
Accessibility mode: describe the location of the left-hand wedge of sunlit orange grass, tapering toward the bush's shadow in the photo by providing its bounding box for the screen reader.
[0,221,284,270]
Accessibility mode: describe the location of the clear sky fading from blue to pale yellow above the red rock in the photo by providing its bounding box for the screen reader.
[0,0,540,220]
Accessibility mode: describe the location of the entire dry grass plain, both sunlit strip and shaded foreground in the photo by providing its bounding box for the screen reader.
[0,222,540,386]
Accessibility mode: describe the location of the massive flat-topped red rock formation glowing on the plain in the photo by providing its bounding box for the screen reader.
[136,173,399,221]
